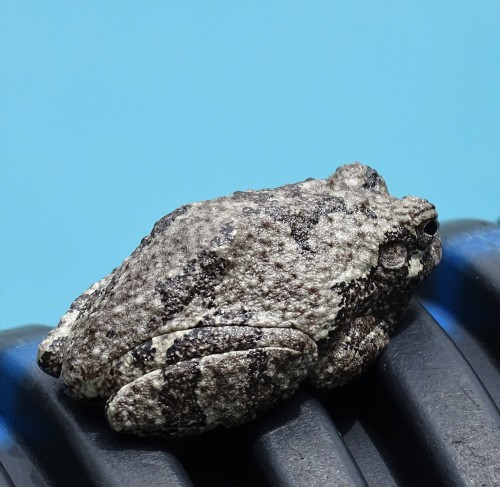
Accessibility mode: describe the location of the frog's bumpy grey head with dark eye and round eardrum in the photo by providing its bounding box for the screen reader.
[329,163,441,328]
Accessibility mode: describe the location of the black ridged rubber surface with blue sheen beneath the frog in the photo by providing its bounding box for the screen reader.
[0,221,500,487]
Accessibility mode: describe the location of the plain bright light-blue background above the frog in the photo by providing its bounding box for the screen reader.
[0,0,500,328]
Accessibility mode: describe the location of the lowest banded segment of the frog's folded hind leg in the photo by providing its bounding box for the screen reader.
[106,347,312,436]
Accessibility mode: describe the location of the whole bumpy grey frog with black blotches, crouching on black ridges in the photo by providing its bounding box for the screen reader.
[38,163,441,436]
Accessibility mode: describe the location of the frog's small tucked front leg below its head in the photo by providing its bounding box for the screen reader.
[310,315,391,389]
